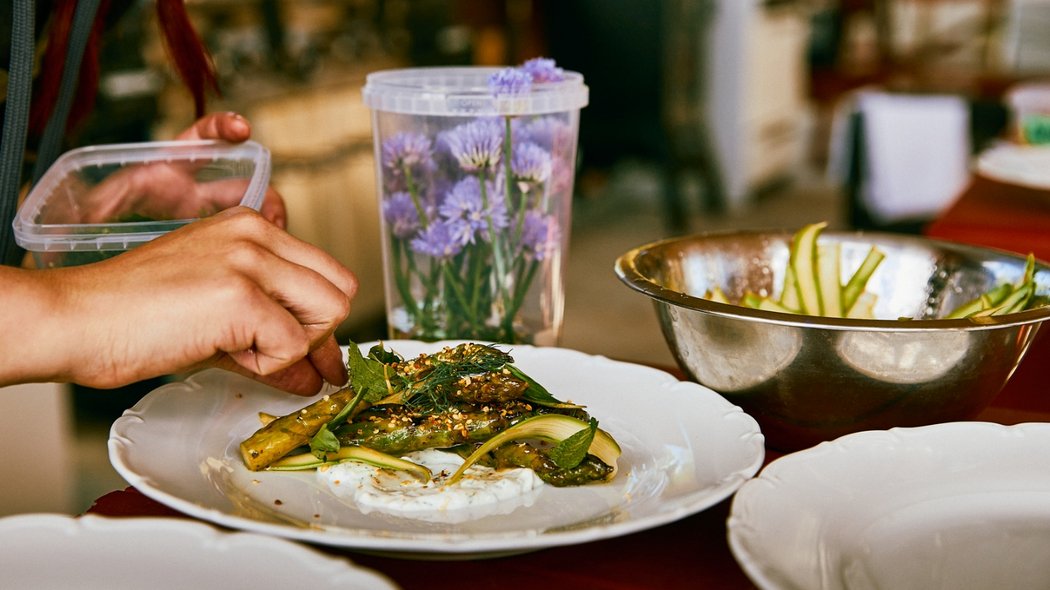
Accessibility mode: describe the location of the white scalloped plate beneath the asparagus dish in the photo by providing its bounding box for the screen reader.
[109,341,764,556]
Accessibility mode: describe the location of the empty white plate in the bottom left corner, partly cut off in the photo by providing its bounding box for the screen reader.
[0,514,394,590]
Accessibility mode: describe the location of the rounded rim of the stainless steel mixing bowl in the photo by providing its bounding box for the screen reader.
[614,230,1050,332]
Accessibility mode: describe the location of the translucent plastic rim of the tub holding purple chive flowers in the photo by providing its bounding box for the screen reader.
[363,67,588,117]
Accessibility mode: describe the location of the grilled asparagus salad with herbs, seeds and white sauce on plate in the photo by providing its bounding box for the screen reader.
[240,342,621,510]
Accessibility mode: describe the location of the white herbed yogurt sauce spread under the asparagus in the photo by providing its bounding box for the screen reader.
[317,443,543,523]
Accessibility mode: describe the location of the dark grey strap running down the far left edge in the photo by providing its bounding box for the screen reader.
[0,0,35,266]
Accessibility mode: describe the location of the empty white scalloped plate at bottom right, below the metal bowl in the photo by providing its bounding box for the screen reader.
[729,422,1050,590]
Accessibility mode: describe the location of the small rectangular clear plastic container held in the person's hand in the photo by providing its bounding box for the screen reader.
[13,141,270,268]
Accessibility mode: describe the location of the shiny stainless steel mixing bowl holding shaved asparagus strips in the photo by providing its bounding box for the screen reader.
[616,227,1050,450]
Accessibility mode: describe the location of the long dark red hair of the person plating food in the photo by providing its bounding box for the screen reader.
[29,0,219,134]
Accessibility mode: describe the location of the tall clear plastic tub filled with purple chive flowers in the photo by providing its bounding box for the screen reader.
[363,62,588,345]
